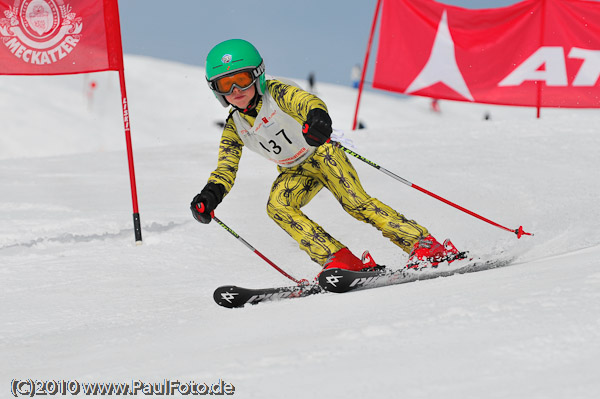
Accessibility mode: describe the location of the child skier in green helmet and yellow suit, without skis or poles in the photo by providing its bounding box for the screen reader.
[191,39,458,271]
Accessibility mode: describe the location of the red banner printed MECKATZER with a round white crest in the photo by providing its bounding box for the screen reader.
[0,0,123,75]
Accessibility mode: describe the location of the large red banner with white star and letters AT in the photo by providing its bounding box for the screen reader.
[373,0,600,108]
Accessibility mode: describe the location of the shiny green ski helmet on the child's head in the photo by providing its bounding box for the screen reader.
[206,39,267,107]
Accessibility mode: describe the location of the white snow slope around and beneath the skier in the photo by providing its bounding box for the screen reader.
[0,57,600,399]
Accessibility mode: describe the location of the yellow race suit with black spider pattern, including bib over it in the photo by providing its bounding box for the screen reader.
[208,80,429,265]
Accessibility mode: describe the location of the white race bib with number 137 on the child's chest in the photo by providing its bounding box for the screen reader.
[232,92,315,168]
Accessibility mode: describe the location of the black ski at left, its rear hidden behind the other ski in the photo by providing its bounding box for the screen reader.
[213,283,324,308]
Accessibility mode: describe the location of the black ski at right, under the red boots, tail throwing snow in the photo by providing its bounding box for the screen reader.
[319,257,514,293]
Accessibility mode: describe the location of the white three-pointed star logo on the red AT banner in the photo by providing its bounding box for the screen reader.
[405,10,475,101]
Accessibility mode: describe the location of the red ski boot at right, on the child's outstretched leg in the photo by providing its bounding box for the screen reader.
[406,234,466,269]
